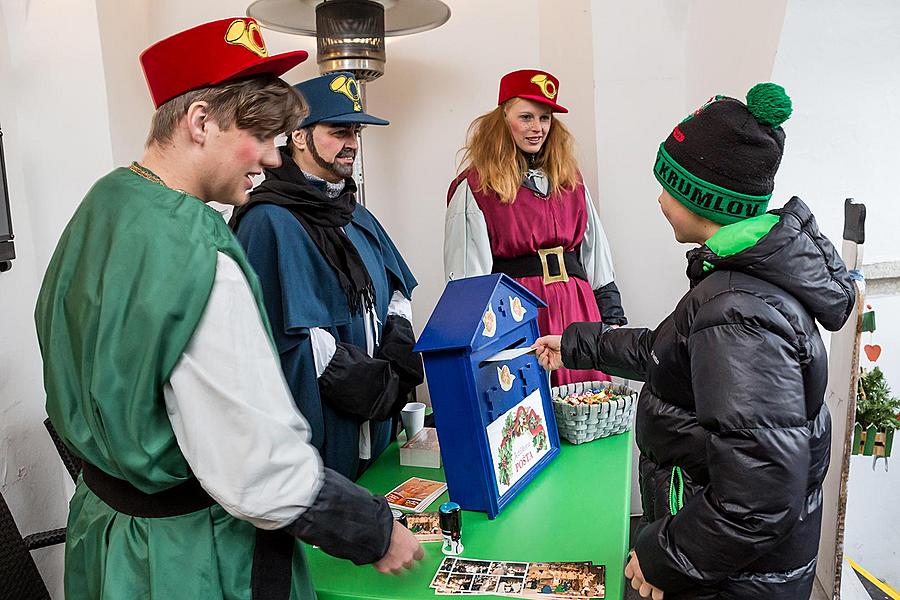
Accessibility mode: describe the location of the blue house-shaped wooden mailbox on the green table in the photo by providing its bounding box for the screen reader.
[415,274,559,519]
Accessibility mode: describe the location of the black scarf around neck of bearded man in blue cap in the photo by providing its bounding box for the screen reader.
[228,146,375,313]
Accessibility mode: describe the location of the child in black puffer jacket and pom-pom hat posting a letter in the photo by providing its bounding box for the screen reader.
[535,83,856,600]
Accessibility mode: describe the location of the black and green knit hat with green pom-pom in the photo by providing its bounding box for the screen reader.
[653,83,792,225]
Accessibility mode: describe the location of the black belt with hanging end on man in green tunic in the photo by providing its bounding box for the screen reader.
[84,462,295,600]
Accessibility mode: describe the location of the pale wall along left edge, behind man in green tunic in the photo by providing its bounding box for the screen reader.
[0,0,111,597]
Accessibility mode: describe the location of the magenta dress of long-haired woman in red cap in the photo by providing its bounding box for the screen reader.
[448,171,610,386]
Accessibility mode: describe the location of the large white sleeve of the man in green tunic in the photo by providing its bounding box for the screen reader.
[164,253,322,529]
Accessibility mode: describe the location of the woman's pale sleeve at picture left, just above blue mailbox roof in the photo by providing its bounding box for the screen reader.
[444,179,494,281]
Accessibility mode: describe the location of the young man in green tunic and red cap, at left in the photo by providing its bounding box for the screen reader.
[35,18,422,600]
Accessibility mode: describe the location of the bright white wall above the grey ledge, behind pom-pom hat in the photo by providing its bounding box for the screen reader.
[773,0,900,262]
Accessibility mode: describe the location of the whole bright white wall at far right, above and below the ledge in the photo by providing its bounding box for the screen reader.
[773,0,900,587]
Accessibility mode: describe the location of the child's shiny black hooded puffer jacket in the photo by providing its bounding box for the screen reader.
[562,198,856,600]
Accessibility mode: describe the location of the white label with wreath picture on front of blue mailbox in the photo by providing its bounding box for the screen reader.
[487,389,550,496]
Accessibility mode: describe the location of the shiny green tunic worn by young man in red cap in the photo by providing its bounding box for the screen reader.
[35,168,315,600]
